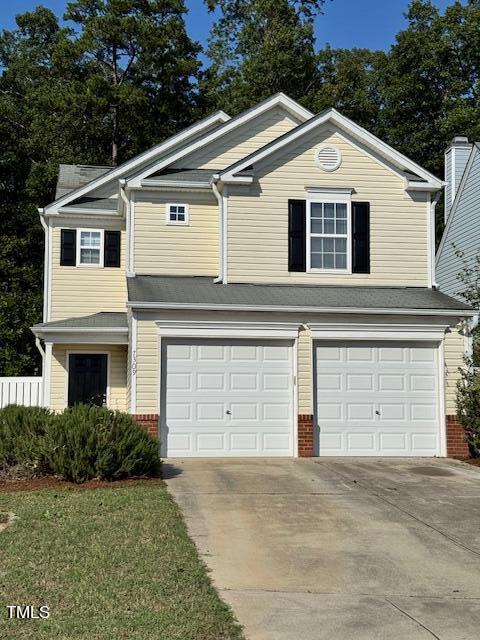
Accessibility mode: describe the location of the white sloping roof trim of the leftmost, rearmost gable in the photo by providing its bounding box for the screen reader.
[44,111,230,213]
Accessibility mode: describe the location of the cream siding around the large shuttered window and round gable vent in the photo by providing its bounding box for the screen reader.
[228,129,428,287]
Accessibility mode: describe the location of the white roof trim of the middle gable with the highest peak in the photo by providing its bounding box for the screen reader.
[127,93,313,188]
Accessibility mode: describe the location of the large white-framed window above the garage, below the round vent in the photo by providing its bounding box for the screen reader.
[307,194,352,273]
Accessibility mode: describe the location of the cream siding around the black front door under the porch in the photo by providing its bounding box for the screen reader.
[50,344,127,411]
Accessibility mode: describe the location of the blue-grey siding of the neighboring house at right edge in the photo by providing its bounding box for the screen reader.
[436,147,480,298]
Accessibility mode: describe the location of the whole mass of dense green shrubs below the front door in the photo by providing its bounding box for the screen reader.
[0,405,160,482]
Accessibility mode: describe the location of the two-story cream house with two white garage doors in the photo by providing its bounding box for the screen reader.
[33,94,473,457]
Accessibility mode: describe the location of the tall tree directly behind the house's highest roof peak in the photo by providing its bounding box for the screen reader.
[202,0,325,113]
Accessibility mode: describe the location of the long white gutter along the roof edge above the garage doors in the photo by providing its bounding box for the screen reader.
[127,302,478,317]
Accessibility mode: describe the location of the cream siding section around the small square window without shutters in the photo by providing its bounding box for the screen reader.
[134,190,219,276]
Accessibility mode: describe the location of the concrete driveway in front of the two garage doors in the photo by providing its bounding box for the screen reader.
[166,458,480,640]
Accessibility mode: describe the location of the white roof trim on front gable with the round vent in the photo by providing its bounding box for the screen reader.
[220,109,443,189]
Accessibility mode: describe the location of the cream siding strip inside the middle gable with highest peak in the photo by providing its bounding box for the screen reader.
[172,107,300,169]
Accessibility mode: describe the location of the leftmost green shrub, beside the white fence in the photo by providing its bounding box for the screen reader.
[0,404,54,477]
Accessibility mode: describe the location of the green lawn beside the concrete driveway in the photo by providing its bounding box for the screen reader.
[0,482,243,640]
